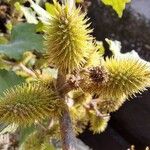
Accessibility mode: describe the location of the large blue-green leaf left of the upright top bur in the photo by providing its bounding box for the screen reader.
[0,23,43,59]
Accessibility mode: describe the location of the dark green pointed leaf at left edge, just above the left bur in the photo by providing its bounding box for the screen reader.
[0,70,24,94]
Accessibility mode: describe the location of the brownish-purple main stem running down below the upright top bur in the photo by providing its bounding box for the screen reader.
[57,74,77,150]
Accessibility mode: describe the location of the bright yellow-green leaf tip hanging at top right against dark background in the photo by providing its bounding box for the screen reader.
[102,0,131,17]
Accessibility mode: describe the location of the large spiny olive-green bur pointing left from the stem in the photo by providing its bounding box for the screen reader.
[0,82,65,126]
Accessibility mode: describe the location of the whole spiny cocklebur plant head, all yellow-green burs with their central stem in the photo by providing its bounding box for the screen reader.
[0,1,150,150]
